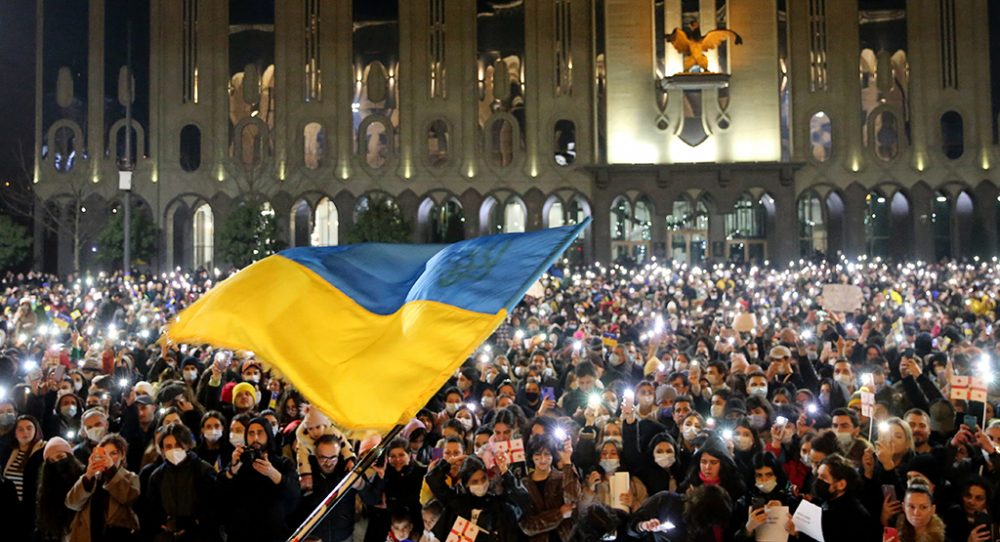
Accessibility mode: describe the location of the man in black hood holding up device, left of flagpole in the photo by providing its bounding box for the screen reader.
[219,418,299,542]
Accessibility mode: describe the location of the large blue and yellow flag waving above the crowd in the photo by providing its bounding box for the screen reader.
[166,219,589,431]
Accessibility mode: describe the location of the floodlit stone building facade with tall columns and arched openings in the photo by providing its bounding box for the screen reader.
[34,0,1000,272]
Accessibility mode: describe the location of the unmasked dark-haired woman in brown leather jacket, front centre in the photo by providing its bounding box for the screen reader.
[521,433,580,542]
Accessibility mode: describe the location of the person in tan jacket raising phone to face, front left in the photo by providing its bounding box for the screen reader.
[65,433,139,542]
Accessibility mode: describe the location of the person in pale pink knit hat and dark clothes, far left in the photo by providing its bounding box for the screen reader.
[35,437,84,542]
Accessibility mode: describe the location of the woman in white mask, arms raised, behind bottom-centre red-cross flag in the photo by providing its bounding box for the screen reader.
[426,454,531,542]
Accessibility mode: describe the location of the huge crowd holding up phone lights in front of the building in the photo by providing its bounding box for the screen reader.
[0,260,1000,542]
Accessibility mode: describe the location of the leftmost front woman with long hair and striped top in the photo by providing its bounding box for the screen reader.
[0,415,45,540]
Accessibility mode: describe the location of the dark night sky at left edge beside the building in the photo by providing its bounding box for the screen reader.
[0,0,35,185]
